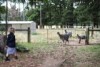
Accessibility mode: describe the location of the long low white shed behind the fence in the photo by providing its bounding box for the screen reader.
[0,21,36,32]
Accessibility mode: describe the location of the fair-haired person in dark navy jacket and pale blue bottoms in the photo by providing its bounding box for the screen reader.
[5,27,18,61]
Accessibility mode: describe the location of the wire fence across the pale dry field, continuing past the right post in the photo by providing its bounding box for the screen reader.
[0,28,100,44]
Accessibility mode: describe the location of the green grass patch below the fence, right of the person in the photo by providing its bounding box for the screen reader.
[16,42,56,52]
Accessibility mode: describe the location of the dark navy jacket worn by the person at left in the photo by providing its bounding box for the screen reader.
[7,33,16,48]
